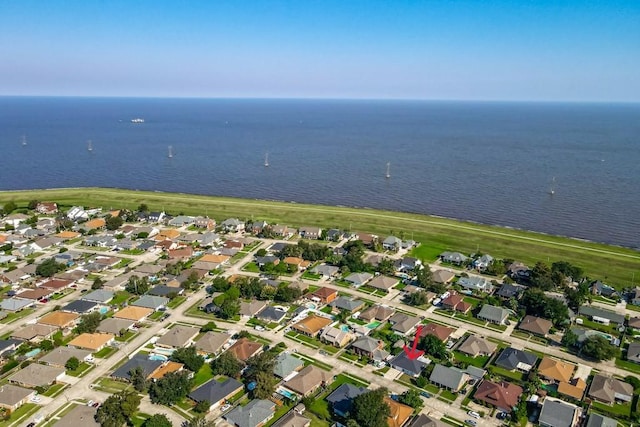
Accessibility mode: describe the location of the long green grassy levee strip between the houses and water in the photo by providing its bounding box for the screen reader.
[0,188,640,287]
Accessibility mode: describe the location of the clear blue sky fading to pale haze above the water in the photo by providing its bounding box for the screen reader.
[0,0,640,102]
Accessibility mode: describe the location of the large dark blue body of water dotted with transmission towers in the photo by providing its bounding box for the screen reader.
[0,98,640,248]
